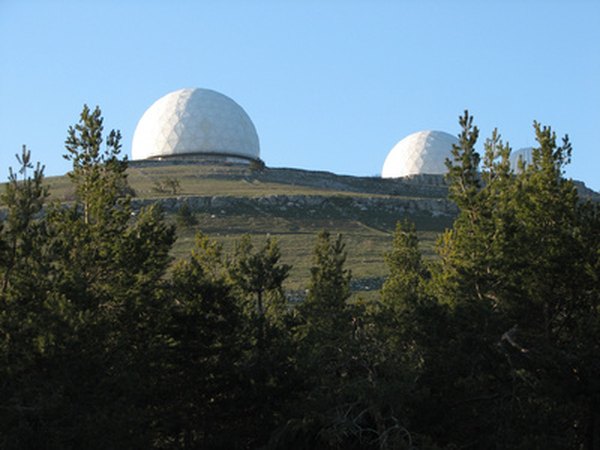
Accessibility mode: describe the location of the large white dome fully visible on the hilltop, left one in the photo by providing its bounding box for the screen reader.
[131,89,259,160]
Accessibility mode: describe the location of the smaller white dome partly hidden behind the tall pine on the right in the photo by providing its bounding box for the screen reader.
[381,131,458,178]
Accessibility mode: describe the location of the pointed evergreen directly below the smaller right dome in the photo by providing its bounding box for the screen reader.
[376,221,450,448]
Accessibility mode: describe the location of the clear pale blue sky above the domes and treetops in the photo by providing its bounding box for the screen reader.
[0,0,600,191]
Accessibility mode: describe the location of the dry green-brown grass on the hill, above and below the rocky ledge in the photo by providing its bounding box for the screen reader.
[5,164,450,297]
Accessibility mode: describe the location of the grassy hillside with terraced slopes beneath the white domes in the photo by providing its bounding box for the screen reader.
[18,162,458,291]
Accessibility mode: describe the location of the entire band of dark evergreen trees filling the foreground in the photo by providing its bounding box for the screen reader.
[0,107,600,449]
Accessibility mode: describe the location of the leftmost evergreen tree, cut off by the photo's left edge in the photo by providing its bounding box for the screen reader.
[0,146,54,448]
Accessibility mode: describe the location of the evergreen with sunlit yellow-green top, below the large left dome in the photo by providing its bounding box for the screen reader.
[157,235,249,449]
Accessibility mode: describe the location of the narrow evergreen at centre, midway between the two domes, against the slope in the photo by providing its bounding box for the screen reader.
[277,231,357,448]
